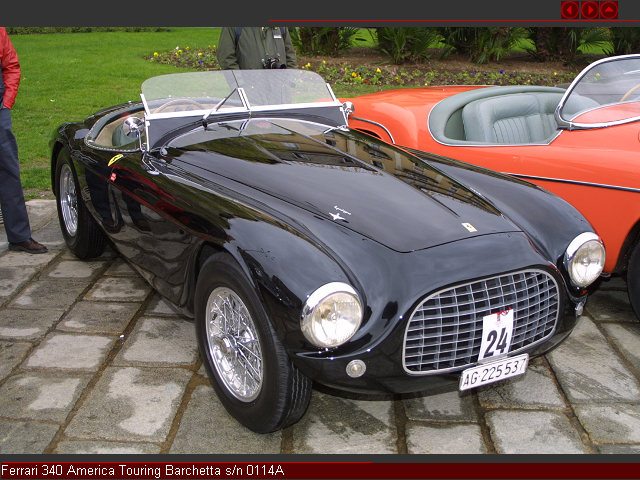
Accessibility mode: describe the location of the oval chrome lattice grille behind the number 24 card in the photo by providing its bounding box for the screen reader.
[403,270,560,374]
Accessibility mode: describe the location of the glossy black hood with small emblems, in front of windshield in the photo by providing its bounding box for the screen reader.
[169,119,520,252]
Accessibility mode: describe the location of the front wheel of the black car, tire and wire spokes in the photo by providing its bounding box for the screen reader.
[195,253,311,433]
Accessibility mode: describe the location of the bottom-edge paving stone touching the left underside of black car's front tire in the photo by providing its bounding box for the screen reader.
[169,385,282,454]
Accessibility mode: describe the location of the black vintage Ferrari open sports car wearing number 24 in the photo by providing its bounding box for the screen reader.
[51,70,605,432]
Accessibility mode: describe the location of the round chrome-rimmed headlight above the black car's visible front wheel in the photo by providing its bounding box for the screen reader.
[301,282,362,348]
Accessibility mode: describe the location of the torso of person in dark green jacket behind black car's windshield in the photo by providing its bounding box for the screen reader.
[217,27,297,70]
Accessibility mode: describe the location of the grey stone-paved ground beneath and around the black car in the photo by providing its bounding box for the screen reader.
[0,200,640,454]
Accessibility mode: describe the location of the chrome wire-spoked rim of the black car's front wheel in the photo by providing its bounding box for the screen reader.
[205,287,263,402]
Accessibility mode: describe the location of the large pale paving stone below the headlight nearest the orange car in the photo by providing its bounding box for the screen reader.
[547,316,640,403]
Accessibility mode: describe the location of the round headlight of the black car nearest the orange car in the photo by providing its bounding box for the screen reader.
[564,232,605,287]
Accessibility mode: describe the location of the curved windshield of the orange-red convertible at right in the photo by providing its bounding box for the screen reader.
[558,55,640,128]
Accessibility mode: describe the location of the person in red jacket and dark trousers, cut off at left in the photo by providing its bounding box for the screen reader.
[0,27,47,253]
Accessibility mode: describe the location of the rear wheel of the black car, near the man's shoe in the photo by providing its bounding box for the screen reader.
[55,148,106,259]
